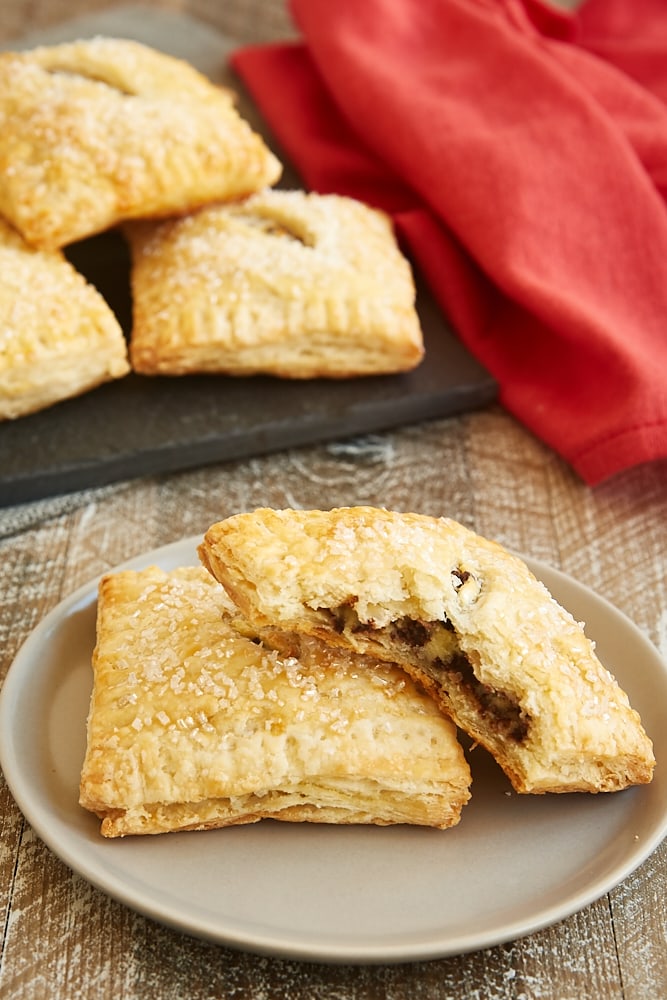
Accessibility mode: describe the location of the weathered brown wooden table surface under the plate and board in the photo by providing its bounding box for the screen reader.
[0,0,667,1000]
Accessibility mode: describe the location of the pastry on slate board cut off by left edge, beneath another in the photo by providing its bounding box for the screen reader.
[0,220,130,420]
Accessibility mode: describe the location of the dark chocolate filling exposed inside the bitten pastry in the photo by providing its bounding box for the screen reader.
[319,604,531,743]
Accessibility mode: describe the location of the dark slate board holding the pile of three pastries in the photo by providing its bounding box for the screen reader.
[0,7,496,506]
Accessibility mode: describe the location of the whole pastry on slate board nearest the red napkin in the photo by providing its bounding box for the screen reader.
[126,190,423,378]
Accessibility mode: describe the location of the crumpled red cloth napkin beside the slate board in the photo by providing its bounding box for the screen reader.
[233,0,667,484]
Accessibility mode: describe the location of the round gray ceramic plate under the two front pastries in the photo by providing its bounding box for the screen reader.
[0,539,667,963]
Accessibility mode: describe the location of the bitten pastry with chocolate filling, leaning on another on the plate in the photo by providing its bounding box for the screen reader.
[199,507,655,792]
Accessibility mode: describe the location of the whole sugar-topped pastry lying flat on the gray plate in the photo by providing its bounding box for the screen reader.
[80,567,470,837]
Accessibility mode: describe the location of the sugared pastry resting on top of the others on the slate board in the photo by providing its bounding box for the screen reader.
[0,38,282,248]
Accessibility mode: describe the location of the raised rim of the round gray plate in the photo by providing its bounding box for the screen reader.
[0,534,667,965]
